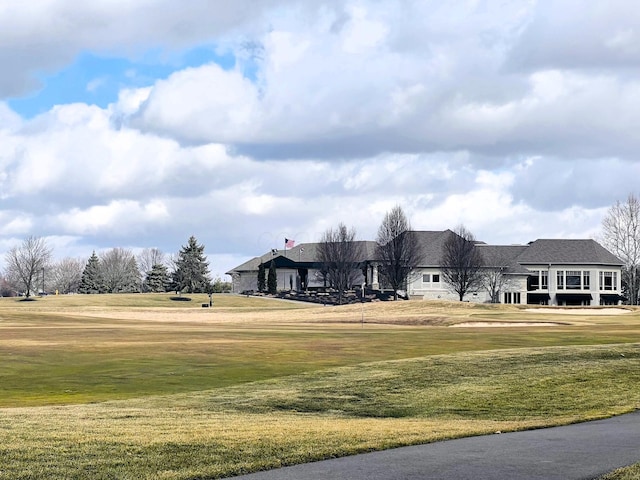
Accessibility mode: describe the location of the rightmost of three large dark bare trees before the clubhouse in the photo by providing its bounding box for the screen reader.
[442,225,483,301]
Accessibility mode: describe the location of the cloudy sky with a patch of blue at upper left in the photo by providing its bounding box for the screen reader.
[0,0,640,280]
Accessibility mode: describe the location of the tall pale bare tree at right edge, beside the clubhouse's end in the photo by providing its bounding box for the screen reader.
[602,194,640,305]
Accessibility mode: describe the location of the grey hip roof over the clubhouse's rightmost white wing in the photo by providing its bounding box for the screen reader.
[518,239,622,265]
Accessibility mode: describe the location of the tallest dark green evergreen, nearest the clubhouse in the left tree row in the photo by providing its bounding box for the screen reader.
[173,235,211,293]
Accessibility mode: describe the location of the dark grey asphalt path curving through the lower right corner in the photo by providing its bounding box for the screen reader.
[228,411,640,480]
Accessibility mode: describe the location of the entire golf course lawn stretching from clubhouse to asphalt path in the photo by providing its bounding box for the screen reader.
[0,295,640,479]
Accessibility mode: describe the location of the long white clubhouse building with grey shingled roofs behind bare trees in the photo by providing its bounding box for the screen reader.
[227,230,623,306]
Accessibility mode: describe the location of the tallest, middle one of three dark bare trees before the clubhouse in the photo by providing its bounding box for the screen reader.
[376,205,420,300]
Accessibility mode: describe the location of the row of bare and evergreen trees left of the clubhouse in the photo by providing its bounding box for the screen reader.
[0,236,231,297]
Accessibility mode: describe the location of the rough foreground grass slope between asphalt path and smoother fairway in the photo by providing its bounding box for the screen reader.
[0,344,640,479]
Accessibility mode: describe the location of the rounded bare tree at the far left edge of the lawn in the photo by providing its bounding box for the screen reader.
[5,236,51,298]
